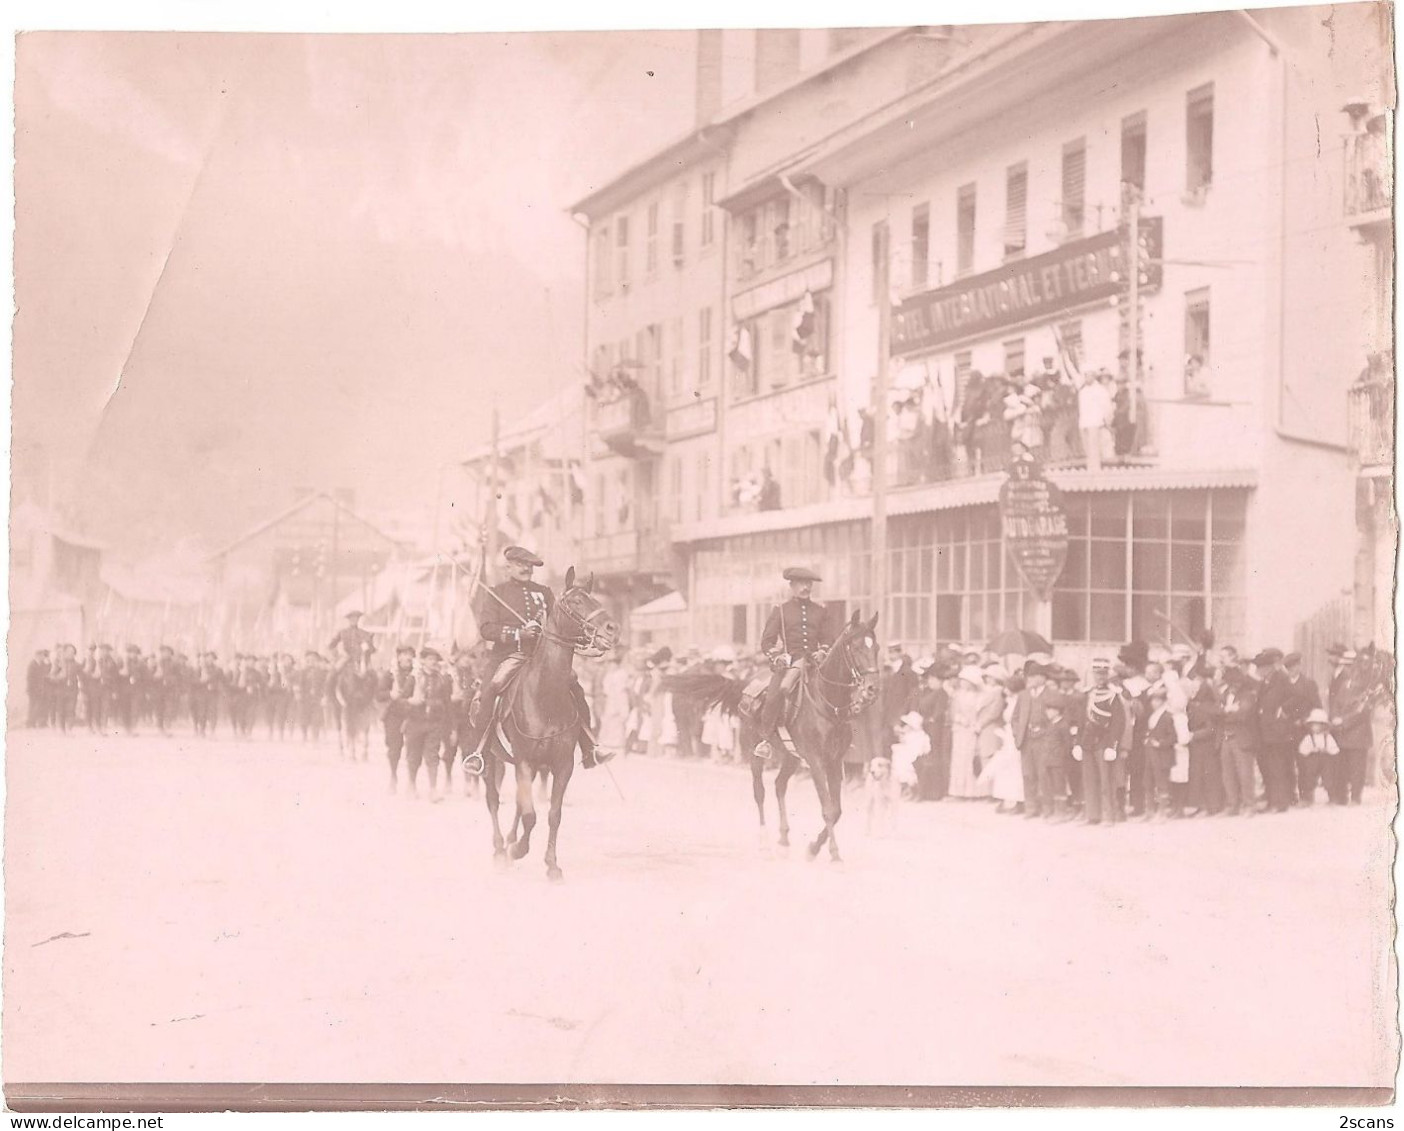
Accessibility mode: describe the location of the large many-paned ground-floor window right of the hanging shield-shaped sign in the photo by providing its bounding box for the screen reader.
[1053,491,1247,643]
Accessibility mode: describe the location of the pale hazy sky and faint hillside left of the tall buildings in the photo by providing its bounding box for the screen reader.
[14,31,694,549]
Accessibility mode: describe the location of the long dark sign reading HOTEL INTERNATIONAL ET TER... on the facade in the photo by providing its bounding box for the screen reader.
[892,216,1163,356]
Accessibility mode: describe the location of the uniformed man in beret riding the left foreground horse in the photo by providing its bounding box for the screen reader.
[470,546,616,769]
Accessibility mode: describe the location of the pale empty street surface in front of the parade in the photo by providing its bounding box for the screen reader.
[3,731,1396,1086]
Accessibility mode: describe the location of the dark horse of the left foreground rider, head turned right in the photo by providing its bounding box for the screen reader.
[483,567,619,880]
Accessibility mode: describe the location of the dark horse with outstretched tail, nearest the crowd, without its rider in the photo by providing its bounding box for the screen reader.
[664,610,878,860]
